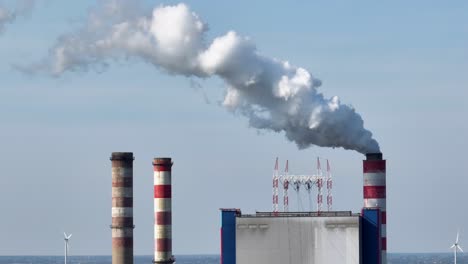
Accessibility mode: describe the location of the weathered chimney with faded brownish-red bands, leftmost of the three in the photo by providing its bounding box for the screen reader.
[110,152,135,264]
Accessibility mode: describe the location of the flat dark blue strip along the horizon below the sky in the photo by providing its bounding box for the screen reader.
[0,253,468,264]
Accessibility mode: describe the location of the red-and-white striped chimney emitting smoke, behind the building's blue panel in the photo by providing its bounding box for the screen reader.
[363,153,387,264]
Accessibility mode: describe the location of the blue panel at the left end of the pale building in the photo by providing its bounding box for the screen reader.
[221,209,240,264]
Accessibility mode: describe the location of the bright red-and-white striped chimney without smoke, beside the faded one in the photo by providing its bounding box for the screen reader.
[153,158,175,264]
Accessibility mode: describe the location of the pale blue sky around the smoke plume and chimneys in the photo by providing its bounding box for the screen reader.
[0,0,468,255]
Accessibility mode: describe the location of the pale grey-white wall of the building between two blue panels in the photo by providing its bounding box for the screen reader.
[236,216,360,264]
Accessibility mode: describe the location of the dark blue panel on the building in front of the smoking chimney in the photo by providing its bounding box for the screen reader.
[361,209,381,264]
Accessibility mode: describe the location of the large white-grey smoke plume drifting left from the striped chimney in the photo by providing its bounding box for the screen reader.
[22,0,379,153]
